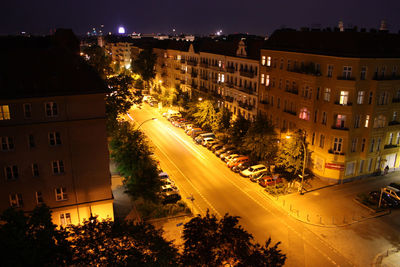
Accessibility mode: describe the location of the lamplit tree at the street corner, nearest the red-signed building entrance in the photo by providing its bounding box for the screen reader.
[275,130,307,184]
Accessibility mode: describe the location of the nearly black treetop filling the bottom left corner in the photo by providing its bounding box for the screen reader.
[0,205,72,266]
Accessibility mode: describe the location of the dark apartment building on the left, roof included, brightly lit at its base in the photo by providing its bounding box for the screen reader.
[0,31,114,225]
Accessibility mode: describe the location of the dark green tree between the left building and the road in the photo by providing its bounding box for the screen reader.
[110,122,161,201]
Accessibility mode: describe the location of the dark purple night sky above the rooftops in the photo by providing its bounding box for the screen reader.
[0,0,400,35]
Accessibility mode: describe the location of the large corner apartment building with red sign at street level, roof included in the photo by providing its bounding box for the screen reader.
[259,30,400,181]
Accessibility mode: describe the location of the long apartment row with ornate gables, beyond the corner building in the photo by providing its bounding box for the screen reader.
[150,38,263,120]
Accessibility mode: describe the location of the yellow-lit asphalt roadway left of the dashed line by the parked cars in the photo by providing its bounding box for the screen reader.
[130,105,357,266]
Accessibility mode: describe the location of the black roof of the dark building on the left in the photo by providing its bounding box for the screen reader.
[0,30,107,99]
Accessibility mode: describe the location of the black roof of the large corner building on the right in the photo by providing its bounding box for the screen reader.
[263,29,400,58]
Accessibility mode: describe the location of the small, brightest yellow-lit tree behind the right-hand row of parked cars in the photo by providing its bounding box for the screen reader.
[193,100,218,131]
